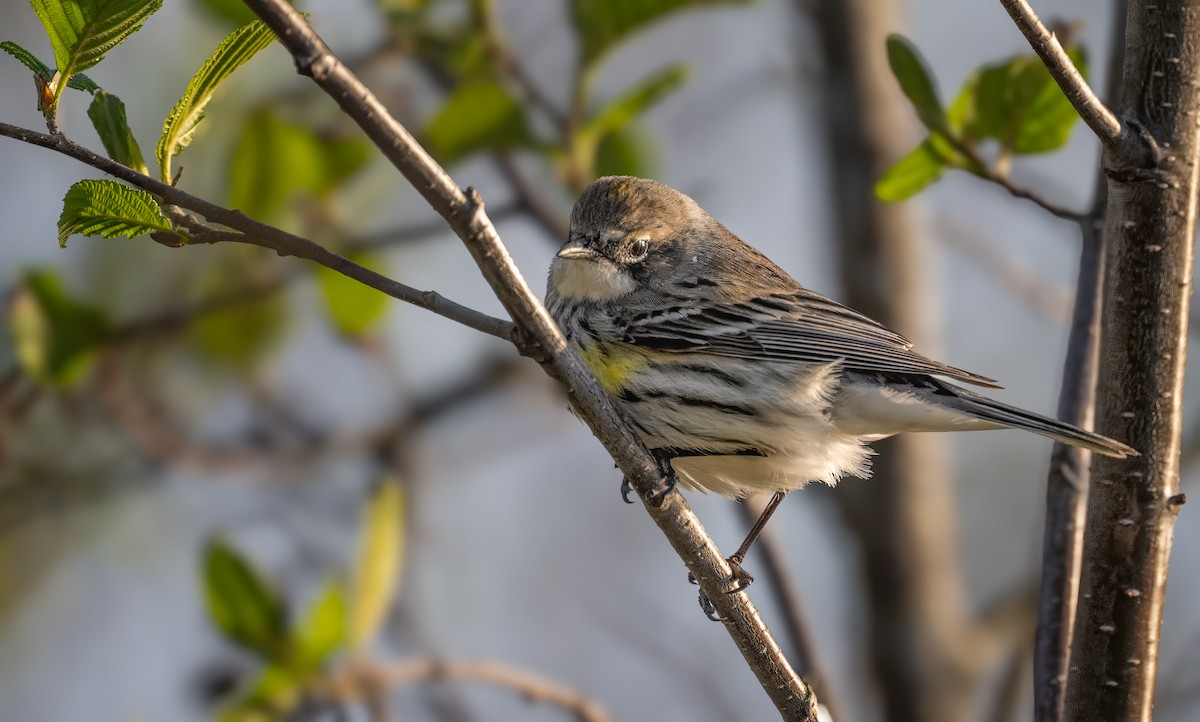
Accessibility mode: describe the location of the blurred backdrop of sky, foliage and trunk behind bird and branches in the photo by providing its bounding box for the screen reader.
[0,0,1200,722]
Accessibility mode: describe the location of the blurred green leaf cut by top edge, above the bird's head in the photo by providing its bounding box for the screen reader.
[571,0,751,67]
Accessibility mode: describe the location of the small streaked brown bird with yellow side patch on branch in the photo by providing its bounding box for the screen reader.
[546,176,1138,588]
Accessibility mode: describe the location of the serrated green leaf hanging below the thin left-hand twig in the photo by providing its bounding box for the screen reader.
[59,180,173,248]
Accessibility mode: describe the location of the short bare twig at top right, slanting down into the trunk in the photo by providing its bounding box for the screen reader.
[1000,0,1124,145]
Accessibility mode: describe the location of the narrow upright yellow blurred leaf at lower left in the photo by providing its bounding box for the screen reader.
[349,479,404,651]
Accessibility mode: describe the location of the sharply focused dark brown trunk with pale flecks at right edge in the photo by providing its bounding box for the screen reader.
[1066,0,1200,722]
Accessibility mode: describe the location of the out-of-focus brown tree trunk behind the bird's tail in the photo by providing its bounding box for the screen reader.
[814,0,973,721]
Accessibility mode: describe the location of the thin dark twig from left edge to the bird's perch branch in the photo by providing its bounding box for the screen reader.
[0,122,514,341]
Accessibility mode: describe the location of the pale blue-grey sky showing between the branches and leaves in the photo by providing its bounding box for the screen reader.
[0,0,1200,722]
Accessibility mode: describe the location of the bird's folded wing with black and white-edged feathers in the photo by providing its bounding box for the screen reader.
[624,289,1000,389]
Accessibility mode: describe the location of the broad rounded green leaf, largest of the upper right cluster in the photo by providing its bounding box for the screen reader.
[973,47,1087,154]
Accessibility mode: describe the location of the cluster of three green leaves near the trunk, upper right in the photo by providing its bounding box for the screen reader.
[875,35,1087,200]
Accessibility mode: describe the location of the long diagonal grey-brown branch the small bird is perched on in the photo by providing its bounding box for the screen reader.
[246,0,816,721]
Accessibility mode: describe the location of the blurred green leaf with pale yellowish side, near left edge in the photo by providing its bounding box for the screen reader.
[8,271,110,386]
